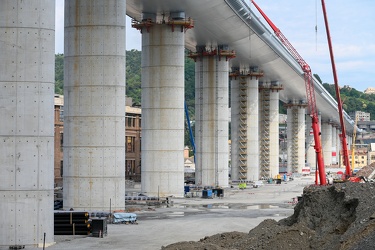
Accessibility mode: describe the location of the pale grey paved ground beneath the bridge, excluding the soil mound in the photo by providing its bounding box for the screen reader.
[19,177,313,250]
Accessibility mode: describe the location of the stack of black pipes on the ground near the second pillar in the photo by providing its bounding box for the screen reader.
[54,211,91,235]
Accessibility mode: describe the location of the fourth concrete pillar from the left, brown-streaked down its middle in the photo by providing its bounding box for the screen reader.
[195,55,229,187]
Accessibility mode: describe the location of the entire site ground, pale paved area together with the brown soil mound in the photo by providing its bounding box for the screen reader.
[22,177,375,250]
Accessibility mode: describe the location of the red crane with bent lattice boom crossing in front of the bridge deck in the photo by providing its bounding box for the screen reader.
[251,0,327,185]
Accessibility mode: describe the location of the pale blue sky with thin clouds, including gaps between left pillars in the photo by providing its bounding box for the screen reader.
[55,0,375,91]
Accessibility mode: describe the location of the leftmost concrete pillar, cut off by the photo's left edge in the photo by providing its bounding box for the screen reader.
[0,0,55,248]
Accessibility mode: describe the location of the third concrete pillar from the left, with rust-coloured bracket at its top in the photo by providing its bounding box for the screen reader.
[141,24,185,197]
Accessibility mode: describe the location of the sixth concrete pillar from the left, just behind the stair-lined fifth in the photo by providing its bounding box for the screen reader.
[259,81,282,179]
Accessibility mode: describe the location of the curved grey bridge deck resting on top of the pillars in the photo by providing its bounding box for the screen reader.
[126,0,353,130]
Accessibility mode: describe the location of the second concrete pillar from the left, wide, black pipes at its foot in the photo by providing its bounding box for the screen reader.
[63,0,126,211]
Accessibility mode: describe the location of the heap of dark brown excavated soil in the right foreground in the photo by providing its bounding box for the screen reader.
[162,182,375,250]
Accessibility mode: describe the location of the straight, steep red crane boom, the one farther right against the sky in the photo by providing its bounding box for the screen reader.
[322,0,354,179]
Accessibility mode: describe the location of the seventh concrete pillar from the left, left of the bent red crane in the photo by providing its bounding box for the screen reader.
[287,102,306,173]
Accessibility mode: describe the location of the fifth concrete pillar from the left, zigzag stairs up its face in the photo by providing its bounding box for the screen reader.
[231,67,263,181]
